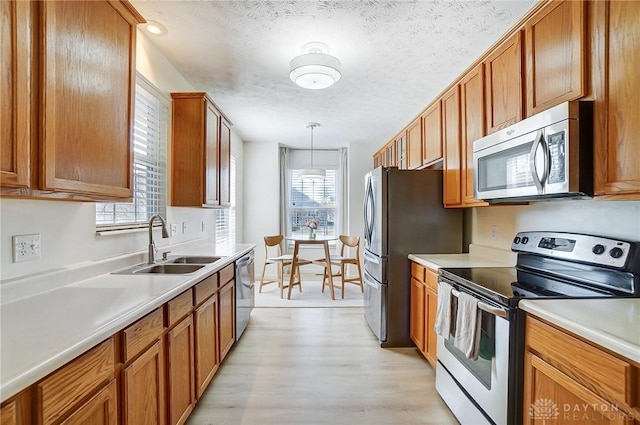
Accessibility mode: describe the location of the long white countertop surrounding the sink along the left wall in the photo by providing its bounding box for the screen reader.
[0,244,255,401]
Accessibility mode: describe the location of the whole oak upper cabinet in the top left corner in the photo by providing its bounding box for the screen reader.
[0,0,144,200]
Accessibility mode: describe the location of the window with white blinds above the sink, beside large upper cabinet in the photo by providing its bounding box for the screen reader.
[96,76,170,231]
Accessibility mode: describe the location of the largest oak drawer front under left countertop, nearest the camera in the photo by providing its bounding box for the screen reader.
[37,338,115,425]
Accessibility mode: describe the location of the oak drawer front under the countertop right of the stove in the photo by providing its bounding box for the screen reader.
[525,316,639,407]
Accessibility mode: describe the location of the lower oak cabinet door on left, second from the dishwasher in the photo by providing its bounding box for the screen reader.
[193,295,220,398]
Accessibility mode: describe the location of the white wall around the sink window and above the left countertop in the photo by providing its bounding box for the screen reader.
[0,31,243,283]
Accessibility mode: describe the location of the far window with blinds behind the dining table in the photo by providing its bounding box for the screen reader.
[286,169,338,236]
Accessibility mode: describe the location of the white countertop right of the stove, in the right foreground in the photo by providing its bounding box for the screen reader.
[518,298,640,364]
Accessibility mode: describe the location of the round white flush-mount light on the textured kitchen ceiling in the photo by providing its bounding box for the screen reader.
[289,41,341,90]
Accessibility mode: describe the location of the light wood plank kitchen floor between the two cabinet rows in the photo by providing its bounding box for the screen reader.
[188,308,457,425]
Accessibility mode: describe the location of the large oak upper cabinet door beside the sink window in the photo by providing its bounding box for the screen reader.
[39,1,138,198]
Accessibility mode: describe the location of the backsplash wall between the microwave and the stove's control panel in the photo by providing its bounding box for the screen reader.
[471,200,640,250]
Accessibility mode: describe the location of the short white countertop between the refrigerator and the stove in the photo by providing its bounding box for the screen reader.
[409,244,516,270]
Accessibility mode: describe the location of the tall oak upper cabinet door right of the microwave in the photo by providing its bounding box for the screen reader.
[593,1,640,200]
